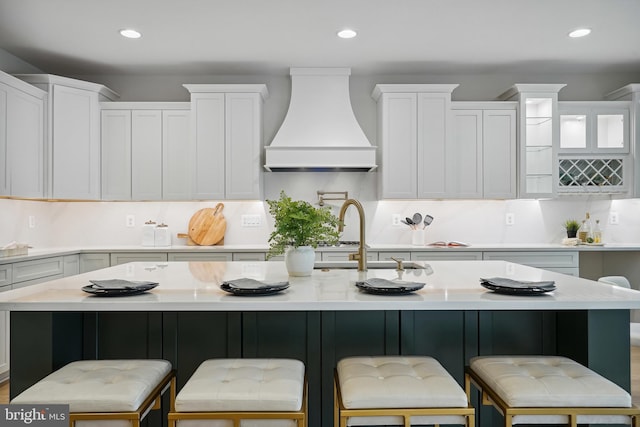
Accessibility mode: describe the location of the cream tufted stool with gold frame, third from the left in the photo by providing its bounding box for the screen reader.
[334,356,475,427]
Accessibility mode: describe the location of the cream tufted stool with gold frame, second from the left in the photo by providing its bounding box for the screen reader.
[169,359,307,427]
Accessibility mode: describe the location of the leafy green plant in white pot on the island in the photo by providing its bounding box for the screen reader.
[267,191,340,276]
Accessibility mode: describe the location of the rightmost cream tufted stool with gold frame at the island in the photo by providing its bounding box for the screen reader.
[465,356,640,427]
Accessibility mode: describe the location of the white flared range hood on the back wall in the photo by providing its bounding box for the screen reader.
[264,68,376,172]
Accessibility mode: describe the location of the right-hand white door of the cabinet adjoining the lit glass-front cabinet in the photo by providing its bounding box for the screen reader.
[482,110,517,199]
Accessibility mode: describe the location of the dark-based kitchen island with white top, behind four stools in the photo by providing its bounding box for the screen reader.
[0,261,640,427]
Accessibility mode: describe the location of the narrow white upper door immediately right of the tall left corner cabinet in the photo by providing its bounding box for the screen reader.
[100,110,131,200]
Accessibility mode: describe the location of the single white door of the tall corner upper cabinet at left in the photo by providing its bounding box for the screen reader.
[52,85,100,200]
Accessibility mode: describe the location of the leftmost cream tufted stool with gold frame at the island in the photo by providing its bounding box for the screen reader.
[11,360,175,427]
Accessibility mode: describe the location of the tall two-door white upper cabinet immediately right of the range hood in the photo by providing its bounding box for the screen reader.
[372,84,458,199]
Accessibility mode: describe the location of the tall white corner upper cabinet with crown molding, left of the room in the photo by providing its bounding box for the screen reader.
[17,74,118,200]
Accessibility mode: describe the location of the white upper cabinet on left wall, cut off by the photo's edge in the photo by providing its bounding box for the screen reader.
[0,72,47,198]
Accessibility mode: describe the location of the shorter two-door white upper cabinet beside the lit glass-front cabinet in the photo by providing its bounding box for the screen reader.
[447,102,517,199]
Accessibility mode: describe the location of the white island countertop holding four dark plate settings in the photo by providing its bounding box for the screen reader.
[0,261,640,311]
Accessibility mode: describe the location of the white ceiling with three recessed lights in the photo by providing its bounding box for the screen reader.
[0,0,640,75]
